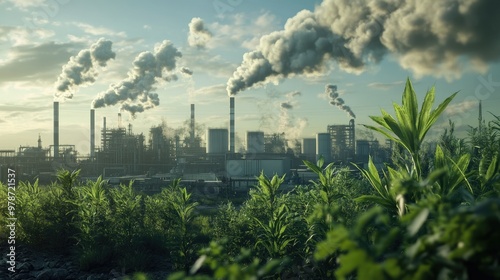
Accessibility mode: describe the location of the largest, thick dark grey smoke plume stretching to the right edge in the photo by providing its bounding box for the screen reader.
[226,0,500,95]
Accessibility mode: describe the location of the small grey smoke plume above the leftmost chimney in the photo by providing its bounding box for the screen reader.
[55,38,116,98]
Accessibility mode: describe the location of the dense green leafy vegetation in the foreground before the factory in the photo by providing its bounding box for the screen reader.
[0,77,500,279]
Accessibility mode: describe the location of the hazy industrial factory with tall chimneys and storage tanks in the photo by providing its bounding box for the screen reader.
[0,97,387,189]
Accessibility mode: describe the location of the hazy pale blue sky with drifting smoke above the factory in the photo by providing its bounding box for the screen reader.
[0,0,500,156]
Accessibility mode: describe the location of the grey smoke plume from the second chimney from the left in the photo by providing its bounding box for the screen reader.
[92,40,182,116]
